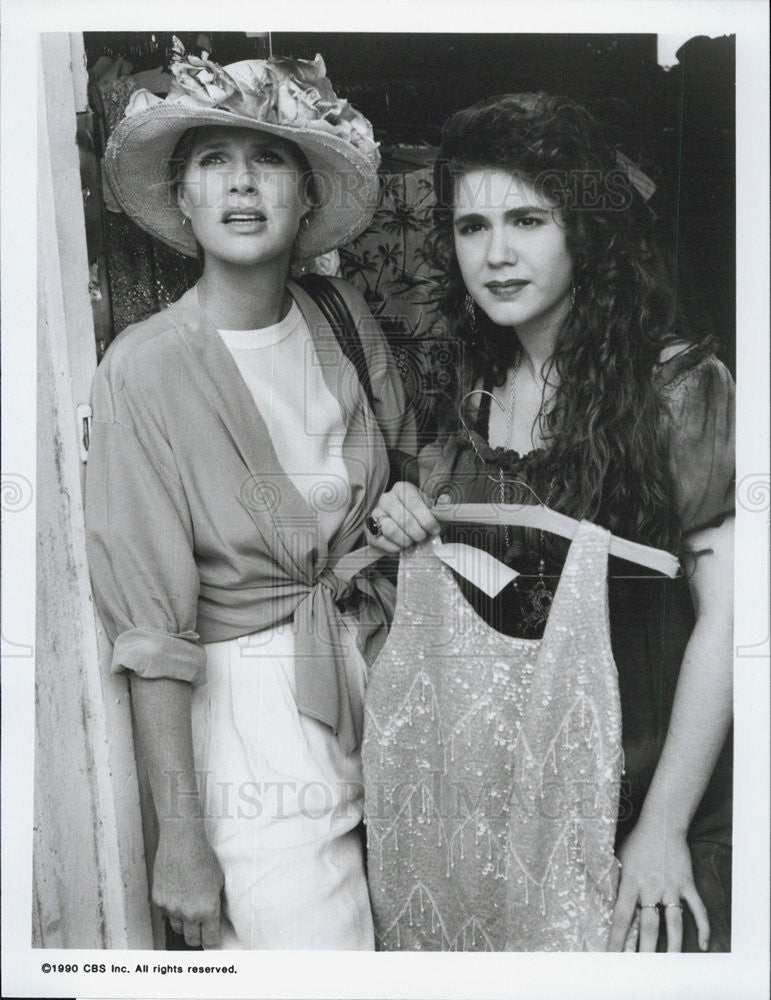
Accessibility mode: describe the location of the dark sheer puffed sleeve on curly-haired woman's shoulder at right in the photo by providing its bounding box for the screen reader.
[664,357,736,534]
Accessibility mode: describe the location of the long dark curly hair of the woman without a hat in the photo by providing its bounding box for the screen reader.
[428,94,704,548]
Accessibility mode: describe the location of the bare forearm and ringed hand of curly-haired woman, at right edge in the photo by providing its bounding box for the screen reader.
[609,518,733,951]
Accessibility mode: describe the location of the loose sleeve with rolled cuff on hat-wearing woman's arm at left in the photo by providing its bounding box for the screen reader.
[86,372,206,683]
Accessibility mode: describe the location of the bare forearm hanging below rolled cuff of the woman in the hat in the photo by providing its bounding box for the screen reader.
[131,674,224,948]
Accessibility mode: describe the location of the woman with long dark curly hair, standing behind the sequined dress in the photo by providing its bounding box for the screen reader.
[365,94,734,951]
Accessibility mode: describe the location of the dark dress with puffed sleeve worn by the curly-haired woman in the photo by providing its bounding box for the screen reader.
[420,347,735,951]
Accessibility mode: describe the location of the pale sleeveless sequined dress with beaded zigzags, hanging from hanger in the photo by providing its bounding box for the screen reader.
[363,522,622,951]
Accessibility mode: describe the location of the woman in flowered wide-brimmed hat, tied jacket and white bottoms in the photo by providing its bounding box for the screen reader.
[87,45,415,949]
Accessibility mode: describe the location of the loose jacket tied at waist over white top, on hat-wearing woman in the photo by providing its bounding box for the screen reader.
[86,281,416,745]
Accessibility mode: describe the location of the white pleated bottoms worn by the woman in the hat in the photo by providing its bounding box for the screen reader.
[193,624,374,950]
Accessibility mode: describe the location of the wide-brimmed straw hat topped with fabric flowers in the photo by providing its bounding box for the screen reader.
[105,40,380,258]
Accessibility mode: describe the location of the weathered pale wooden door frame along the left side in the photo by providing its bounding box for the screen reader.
[32,33,153,948]
